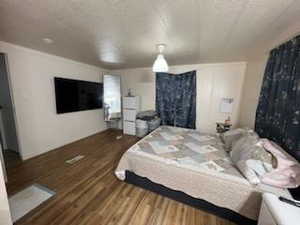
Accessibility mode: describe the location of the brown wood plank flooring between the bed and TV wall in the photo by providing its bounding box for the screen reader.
[7,130,233,225]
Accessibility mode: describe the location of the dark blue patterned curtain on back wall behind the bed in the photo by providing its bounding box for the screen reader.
[156,71,196,129]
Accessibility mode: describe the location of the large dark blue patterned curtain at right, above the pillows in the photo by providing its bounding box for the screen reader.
[255,36,300,160]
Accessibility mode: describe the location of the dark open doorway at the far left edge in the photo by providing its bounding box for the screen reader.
[0,53,22,176]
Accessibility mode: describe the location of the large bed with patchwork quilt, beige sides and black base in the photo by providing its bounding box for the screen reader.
[115,126,290,224]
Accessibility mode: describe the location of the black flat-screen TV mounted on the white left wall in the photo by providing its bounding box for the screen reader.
[54,77,103,114]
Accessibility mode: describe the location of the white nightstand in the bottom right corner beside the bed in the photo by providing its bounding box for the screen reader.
[258,193,300,225]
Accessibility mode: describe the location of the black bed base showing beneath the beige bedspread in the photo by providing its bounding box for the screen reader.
[125,170,257,225]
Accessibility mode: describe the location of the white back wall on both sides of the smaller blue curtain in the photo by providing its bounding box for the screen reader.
[111,62,246,132]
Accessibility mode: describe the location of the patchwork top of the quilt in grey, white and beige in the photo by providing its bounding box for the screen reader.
[129,126,244,180]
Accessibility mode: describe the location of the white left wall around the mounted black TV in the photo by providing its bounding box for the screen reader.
[0,42,106,159]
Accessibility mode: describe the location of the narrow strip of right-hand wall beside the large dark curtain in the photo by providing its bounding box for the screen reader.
[239,55,268,129]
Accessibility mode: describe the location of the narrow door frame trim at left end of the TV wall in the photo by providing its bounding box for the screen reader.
[0,51,24,161]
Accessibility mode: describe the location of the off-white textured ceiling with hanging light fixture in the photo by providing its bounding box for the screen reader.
[0,0,300,69]
